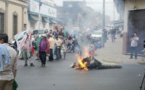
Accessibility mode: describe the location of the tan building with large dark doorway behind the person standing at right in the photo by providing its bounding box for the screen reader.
[114,0,145,54]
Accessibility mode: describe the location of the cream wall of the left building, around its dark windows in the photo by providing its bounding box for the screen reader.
[0,0,28,39]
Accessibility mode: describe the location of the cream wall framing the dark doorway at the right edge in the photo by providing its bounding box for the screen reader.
[123,0,145,54]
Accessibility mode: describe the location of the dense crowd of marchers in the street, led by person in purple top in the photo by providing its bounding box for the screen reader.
[21,29,76,67]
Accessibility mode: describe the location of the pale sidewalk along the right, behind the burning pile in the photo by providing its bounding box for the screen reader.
[96,36,145,64]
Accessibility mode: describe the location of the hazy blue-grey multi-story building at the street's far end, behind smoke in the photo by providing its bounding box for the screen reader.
[57,0,86,25]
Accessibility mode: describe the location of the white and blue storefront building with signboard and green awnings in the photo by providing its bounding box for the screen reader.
[28,0,57,30]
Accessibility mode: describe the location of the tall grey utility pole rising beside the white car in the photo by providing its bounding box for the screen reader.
[102,0,105,47]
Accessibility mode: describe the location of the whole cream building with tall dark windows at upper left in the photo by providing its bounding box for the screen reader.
[0,0,28,38]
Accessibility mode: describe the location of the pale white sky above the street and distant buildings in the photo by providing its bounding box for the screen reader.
[54,0,119,20]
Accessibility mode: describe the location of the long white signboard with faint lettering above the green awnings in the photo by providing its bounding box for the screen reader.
[29,0,57,18]
